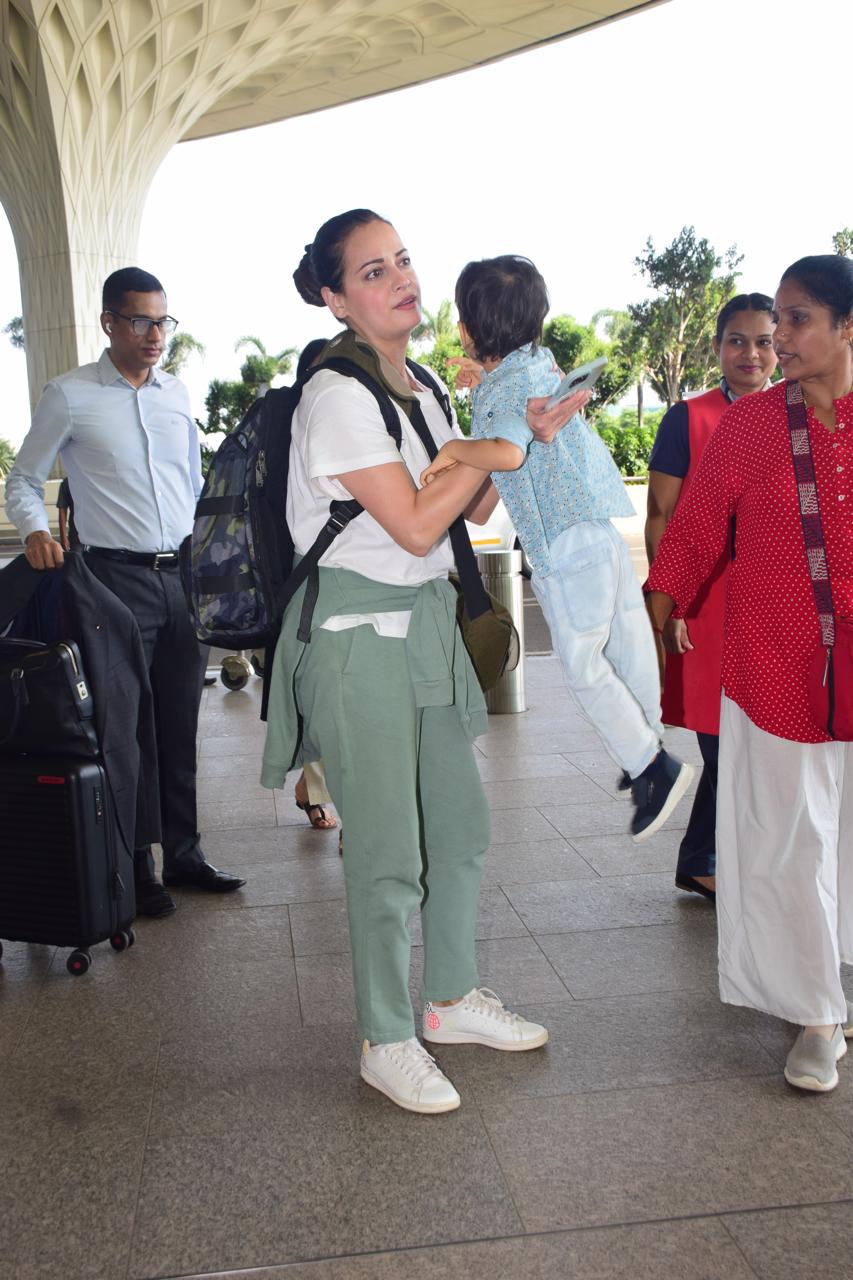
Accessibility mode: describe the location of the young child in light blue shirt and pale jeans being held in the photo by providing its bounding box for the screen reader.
[421,255,694,844]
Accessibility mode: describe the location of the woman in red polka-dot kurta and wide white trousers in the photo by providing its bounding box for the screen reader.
[649,255,853,1092]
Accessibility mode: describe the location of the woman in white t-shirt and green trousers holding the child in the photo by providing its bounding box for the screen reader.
[263,210,576,1112]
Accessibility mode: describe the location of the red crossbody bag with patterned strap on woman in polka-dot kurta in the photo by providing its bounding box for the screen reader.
[785,381,853,742]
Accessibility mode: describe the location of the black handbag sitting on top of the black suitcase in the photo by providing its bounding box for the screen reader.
[0,637,99,759]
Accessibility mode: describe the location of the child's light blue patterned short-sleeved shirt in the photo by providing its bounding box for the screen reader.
[471,346,634,577]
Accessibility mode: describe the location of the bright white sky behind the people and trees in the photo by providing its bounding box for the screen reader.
[0,0,853,442]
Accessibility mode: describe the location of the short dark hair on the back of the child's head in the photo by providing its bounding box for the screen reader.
[456,253,551,360]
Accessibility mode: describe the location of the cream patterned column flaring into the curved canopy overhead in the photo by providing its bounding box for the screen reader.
[0,0,665,397]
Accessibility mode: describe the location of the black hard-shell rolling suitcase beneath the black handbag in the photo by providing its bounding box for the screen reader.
[0,754,136,974]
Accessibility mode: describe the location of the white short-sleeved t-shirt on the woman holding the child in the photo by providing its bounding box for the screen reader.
[287,370,461,636]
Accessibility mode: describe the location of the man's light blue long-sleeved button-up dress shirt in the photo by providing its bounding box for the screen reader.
[6,351,201,552]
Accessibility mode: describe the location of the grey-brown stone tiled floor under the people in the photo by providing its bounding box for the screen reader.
[0,658,853,1280]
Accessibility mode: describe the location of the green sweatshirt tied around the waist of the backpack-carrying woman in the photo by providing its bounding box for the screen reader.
[261,567,488,788]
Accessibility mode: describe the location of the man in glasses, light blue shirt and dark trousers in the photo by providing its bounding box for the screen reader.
[6,268,245,915]
